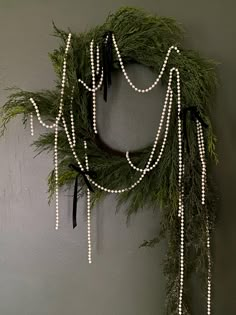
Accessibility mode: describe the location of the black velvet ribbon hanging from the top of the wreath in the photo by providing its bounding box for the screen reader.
[102,31,113,102]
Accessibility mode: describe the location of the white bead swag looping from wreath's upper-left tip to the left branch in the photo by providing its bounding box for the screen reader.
[30,33,71,129]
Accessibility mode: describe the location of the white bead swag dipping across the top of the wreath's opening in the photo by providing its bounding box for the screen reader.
[112,34,180,93]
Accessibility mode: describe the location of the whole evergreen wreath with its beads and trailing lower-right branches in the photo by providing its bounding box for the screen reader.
[1,7,217,315]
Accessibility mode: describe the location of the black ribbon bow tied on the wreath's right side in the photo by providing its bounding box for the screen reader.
[180,106,208,153]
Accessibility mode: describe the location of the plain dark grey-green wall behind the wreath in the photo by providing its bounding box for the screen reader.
[0,0,236,315]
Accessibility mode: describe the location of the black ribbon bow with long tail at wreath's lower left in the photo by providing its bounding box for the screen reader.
[69,164,95,229]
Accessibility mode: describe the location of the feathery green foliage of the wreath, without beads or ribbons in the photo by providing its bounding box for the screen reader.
[1,8,217,315]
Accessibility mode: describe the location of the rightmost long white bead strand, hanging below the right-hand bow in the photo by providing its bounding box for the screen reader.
[196,120,212,315]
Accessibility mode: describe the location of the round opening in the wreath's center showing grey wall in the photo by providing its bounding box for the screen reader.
[97,64,165,152]
